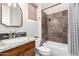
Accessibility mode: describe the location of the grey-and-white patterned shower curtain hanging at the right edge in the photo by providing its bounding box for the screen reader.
[68,3,79,56]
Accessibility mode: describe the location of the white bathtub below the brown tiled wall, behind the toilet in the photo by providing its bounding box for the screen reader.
[43,41,69,56]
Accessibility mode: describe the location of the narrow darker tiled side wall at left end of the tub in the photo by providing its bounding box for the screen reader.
[42,12,48,43]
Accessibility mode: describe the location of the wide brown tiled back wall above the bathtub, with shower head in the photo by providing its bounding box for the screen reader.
[47,10,68,44]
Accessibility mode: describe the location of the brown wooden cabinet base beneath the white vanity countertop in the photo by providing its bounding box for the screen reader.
[0,41,35,56]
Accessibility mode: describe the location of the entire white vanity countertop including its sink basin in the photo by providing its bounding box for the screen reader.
[0,37,35,52]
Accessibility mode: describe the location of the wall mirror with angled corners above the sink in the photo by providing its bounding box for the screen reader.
[1,3,23,27]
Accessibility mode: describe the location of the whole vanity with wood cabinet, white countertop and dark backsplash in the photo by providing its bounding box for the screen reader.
[0,32,35,56]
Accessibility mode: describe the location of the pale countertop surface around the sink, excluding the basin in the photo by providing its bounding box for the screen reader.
[0,37,35,52]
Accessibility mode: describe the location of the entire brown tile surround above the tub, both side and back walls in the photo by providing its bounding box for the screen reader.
[42,10,68,44]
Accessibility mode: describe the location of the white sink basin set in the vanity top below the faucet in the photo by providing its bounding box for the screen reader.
[2,37,29,44]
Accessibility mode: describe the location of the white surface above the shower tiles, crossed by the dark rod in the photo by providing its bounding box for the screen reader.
[41,3,68,15]
